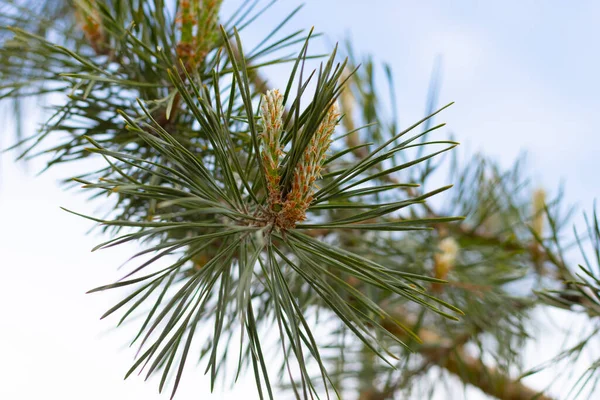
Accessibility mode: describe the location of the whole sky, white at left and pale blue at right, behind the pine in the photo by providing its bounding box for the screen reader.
[0,0,600,400]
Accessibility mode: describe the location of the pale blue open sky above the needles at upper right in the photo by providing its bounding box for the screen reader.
[225,0,600,208]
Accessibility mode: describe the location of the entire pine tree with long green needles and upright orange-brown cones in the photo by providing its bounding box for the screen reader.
[0,0,600,400]
